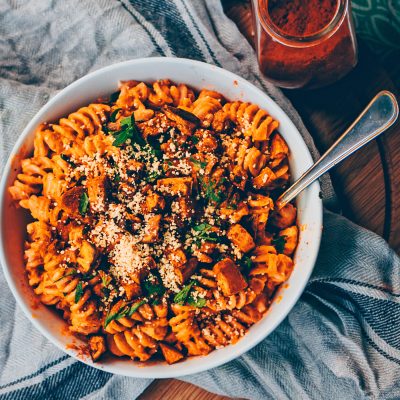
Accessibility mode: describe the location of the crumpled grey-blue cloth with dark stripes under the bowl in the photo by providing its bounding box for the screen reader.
[0,0,400,400]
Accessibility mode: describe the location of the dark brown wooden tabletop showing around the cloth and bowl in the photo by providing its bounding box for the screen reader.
[140,0,400,400]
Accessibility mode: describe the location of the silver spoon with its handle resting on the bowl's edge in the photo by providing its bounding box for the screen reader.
[276,90,399,209]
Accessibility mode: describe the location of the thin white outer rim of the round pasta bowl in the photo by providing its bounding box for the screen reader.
[0,57,323,379]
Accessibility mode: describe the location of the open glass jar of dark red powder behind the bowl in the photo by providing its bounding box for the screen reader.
[252,0,357,88]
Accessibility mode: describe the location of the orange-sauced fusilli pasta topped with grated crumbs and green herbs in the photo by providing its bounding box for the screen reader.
[9,79,299,363]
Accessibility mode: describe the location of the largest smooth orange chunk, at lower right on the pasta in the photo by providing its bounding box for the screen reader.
[213,258,247,296]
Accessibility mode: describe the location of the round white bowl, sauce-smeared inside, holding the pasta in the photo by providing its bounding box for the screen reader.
[0,58,322,378]
